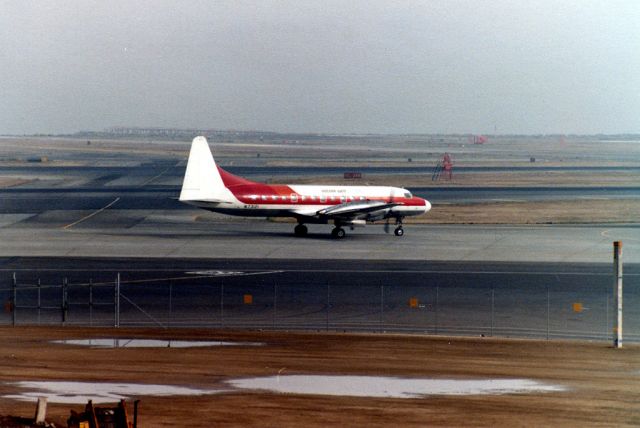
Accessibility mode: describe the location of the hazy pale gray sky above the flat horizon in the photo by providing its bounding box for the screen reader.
[0,0,640,134]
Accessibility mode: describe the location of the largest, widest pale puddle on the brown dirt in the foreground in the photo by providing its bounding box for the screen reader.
[226,375,565,398]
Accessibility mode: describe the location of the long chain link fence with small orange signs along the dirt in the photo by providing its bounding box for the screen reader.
[2,272,640,341]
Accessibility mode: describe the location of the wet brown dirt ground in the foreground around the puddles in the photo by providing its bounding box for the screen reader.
[0,327,640,427]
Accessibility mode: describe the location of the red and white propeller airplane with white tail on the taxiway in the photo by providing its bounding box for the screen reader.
[179,136,431,239]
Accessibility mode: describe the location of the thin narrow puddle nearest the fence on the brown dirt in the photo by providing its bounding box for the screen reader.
[51,339,264,348]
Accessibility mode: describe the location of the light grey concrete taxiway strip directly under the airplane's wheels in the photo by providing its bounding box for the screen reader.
[0,212,640,263]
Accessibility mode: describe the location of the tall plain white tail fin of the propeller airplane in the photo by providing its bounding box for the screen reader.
[180,137,233,202]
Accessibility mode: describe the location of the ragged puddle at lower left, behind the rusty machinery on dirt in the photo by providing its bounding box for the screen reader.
[2,381,225,404]
